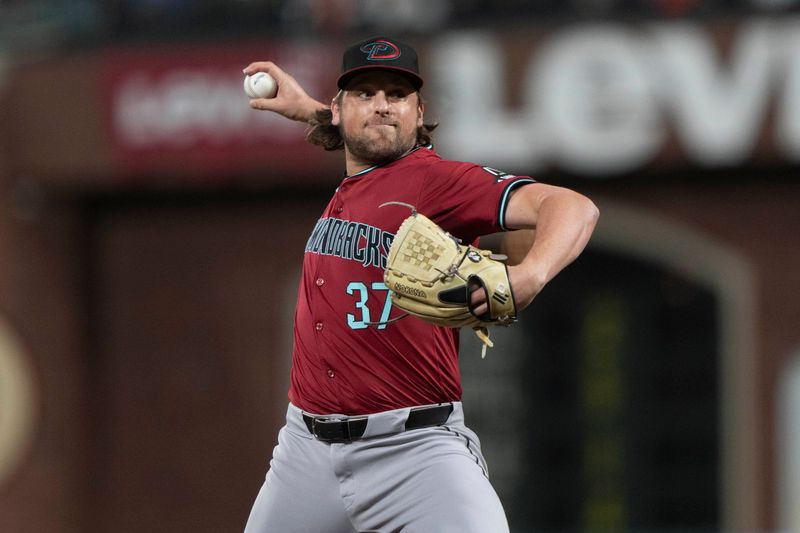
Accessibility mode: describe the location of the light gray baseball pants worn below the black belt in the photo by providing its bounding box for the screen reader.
[245,402,508,533]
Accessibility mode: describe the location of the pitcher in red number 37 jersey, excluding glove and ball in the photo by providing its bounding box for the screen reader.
[244,38,598,533]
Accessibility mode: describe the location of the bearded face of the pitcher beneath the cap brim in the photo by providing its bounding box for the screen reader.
[331,71,424,165]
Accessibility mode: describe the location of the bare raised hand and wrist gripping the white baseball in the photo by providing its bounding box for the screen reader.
[242,61,328,122]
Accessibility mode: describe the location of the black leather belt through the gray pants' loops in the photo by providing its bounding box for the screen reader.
[303,403,453,442]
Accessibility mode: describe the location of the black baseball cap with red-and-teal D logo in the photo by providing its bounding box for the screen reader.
[336,37,422,90]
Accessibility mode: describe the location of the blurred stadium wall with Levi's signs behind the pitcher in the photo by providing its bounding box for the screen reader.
[0,0,800,533]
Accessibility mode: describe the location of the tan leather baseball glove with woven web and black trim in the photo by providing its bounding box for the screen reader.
[384,211,517,355]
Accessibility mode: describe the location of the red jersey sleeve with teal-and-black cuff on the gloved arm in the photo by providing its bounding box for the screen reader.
[418,160,535,242]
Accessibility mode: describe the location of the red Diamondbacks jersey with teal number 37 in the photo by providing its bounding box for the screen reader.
[289,147,533,415]
